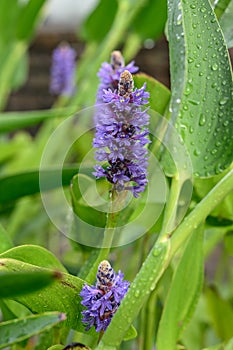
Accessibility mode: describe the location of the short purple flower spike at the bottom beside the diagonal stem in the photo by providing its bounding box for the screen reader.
[80,260,129,332]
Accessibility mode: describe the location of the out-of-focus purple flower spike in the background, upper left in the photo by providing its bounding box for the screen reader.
[50,43,76,96]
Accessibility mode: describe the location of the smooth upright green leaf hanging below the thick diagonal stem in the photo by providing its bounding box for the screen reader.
[156,227,204,350]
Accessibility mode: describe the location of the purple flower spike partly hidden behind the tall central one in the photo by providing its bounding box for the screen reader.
[96,51,138,103]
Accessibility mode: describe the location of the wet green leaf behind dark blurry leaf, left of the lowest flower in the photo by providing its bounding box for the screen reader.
[0,258,84,332]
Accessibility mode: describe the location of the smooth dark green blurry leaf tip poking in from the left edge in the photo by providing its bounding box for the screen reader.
[0,270,61,298]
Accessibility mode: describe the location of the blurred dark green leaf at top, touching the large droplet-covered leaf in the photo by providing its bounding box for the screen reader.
[132,0,167,40]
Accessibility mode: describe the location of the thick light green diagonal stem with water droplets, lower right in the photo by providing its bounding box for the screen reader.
[97,170,233,350]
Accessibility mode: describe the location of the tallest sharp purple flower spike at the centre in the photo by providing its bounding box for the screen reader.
[93,64,150,197]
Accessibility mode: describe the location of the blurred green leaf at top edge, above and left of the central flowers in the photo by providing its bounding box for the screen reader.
[81,0,118,42]
